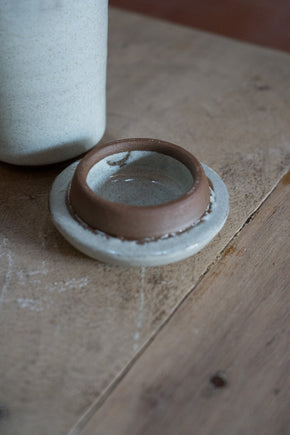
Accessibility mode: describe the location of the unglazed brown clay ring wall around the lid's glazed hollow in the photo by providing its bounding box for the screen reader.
[69,138,210,240]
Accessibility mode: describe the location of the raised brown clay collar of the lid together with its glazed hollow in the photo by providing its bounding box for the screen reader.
[68,138,210,240]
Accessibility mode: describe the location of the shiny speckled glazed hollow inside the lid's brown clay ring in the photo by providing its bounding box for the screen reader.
[86,151,194,206]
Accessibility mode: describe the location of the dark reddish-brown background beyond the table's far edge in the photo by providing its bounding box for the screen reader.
[109,0,290,52]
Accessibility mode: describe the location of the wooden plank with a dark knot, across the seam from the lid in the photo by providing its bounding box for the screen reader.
[81,176,290,435]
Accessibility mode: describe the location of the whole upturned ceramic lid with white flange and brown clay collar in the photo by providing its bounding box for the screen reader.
[49,138,229,266]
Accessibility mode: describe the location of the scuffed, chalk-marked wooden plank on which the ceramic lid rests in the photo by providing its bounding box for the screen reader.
[0,6,290,435]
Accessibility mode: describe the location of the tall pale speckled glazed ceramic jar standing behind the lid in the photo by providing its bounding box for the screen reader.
[0,0,108,165]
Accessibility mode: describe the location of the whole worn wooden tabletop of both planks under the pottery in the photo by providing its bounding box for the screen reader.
[0,9,290,435]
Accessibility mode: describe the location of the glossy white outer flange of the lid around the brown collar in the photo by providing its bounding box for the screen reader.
[50,162,229,266]
